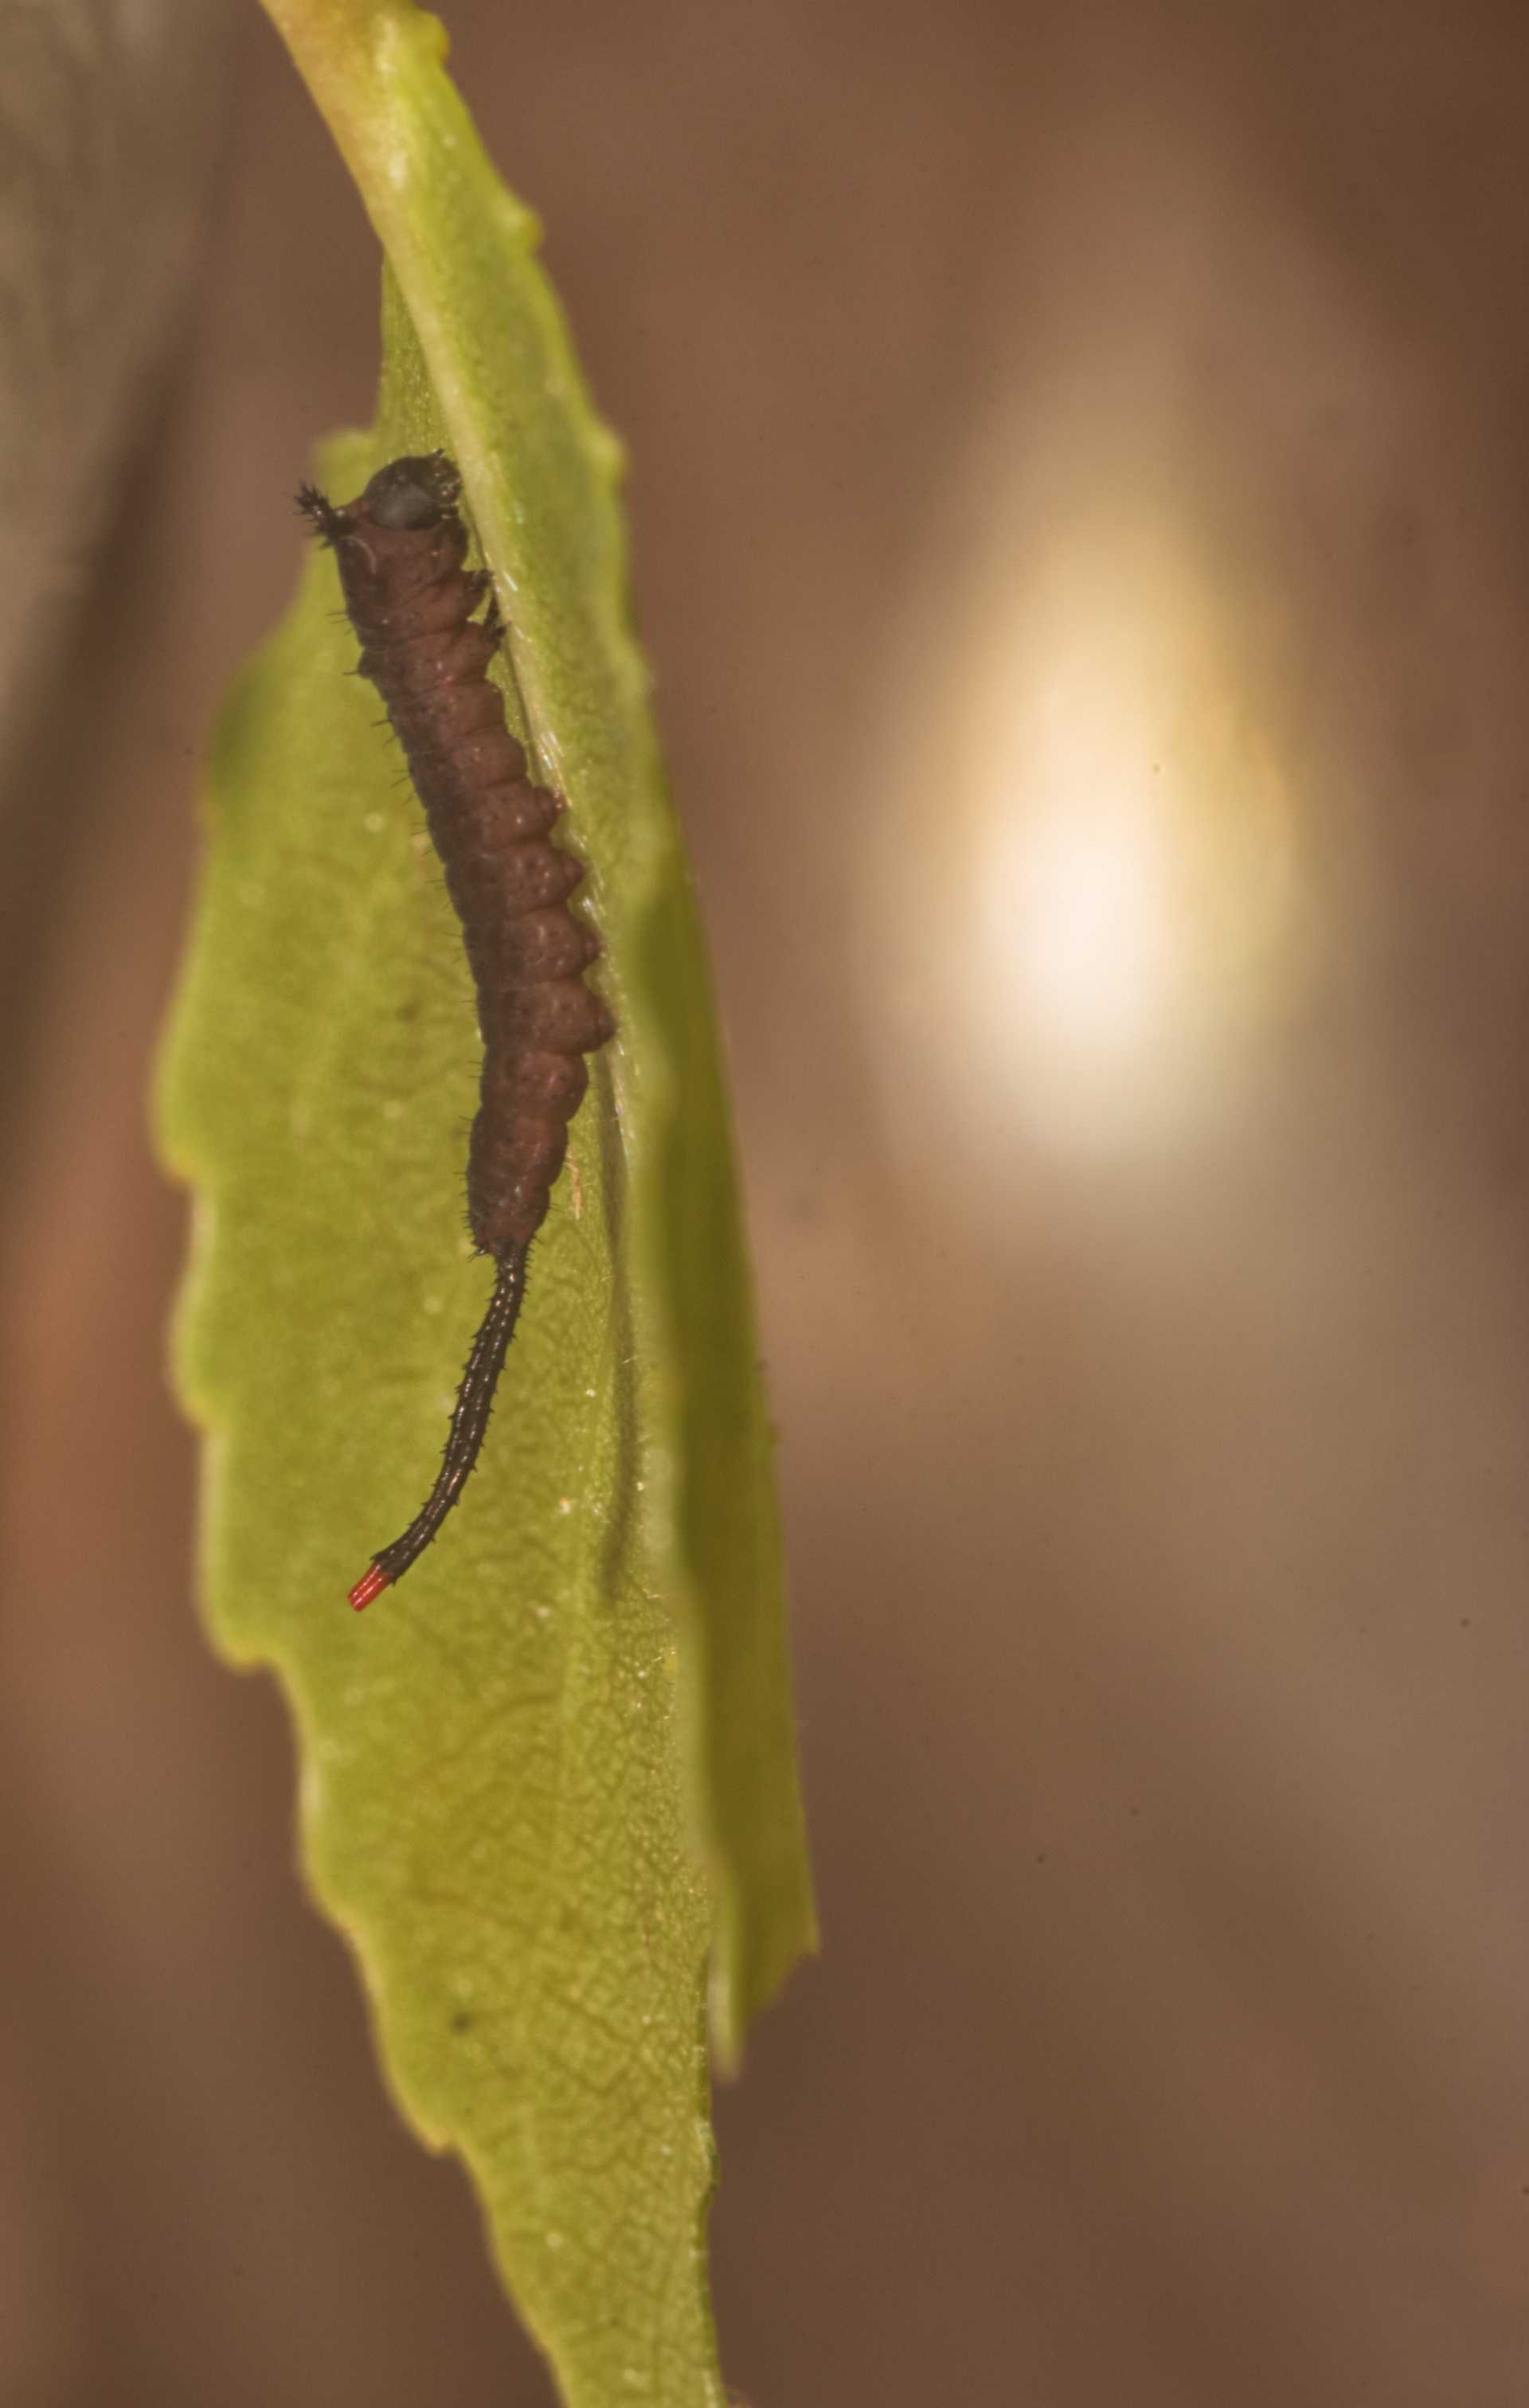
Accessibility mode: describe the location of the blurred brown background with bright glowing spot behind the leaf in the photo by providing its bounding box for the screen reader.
[0,0,1529,2408]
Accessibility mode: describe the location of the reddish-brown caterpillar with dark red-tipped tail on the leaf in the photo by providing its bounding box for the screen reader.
[296,453,616,1611]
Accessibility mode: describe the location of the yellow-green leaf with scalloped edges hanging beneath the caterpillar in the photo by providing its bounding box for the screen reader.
[159,0,814,2408]
